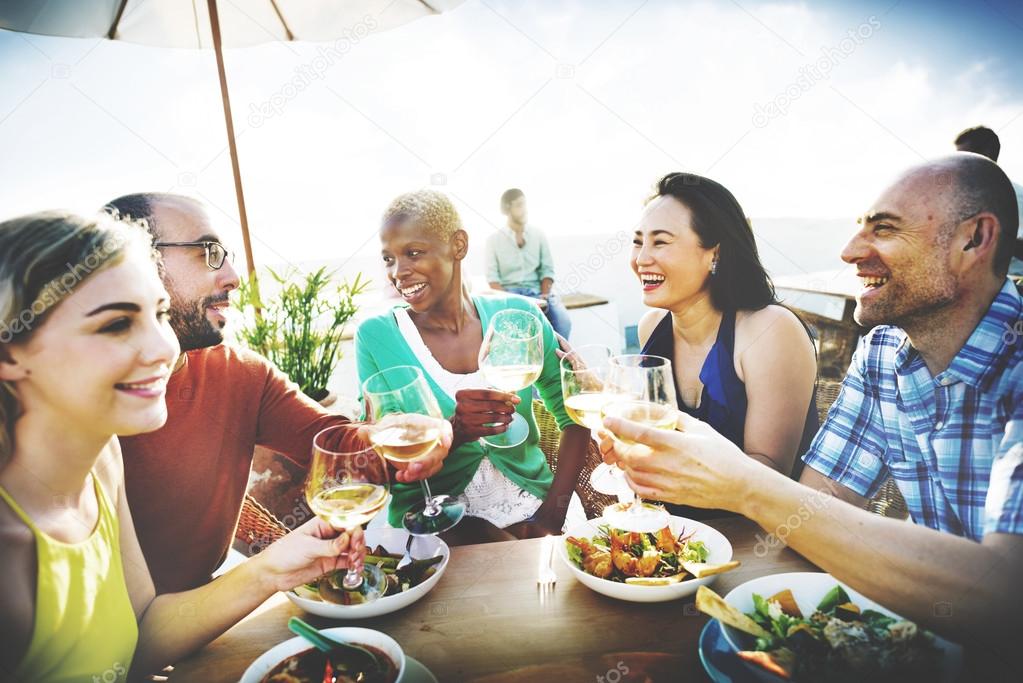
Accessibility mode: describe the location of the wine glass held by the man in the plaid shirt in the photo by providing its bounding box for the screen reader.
[601,355,677,533]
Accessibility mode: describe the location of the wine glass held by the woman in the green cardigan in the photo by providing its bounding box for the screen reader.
[480,309,543,448]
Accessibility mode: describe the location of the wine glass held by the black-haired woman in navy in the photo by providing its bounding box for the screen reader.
[561,344,632,498]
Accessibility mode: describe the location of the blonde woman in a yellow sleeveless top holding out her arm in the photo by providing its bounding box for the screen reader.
[0,213,364,683]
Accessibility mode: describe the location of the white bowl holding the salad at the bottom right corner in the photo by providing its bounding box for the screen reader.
[721,572,963,683]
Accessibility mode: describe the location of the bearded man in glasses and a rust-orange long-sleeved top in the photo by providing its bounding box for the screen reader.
[105,193,446,593]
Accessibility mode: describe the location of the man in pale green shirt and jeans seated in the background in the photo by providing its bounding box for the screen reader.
[484,188,572,339]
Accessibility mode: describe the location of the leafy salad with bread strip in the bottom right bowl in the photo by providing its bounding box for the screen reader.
[696,585,942,683]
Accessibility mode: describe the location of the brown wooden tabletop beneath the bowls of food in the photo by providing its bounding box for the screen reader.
[171,517,815,683]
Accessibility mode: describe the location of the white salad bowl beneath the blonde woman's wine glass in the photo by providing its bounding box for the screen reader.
[284,527,451,619]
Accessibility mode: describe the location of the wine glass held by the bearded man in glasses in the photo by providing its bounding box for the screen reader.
[362,365,465,536]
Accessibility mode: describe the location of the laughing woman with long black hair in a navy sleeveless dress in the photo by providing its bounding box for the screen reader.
[631,173,817,518]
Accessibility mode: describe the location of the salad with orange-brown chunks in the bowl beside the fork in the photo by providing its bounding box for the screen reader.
[565,525,739,586]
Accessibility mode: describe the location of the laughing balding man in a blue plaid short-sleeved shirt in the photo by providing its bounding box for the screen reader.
[602,152,1023,680]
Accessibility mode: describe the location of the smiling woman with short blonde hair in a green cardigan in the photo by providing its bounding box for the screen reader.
[355,190,589,544]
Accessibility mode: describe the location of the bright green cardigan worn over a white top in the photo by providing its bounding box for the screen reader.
[355,294,572,527]
